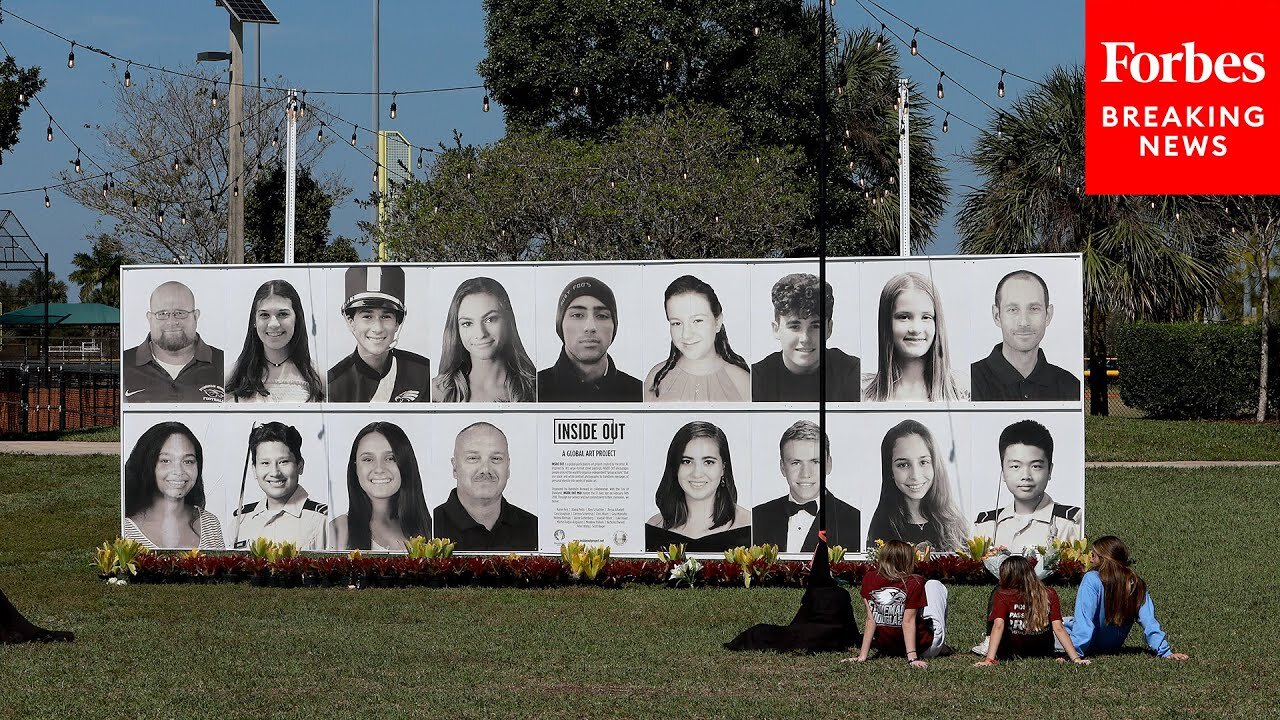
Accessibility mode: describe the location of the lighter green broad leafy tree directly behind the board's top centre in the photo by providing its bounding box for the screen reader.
[367,106,808,261]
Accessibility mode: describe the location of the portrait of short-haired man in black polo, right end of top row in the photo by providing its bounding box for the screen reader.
[969,270,1080,401]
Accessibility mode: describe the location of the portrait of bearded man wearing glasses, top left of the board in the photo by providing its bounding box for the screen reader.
[123,281,224,402]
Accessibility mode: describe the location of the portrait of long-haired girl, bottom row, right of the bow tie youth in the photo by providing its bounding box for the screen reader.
[867,420,969,552]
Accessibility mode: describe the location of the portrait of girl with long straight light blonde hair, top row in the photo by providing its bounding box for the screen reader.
[863,273,970,402]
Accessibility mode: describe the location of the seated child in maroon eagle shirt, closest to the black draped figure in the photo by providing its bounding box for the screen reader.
[841,541,952,667]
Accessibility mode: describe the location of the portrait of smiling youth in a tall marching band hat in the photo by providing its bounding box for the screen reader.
[329,265,431,402]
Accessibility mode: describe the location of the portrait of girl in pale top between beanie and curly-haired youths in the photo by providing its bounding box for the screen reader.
[644,275,751,402]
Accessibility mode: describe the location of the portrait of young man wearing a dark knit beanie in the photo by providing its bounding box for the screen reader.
[538,277,644,402]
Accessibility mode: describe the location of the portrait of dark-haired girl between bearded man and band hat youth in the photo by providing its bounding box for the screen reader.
[227,279,325,402]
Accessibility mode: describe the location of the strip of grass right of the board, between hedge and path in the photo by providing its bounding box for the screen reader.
[1084,415,1280,461]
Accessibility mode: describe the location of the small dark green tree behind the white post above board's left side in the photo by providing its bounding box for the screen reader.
[244,163,360,263]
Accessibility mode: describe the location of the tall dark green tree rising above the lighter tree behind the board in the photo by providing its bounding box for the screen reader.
[479,0,948,255]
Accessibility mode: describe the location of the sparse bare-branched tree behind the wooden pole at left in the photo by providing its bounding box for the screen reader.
[63,70,337,263]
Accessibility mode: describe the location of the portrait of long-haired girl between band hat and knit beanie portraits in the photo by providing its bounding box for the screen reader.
[431,277,538,402]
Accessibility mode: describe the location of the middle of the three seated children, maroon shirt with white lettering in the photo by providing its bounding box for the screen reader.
[974,555,1089,667]
